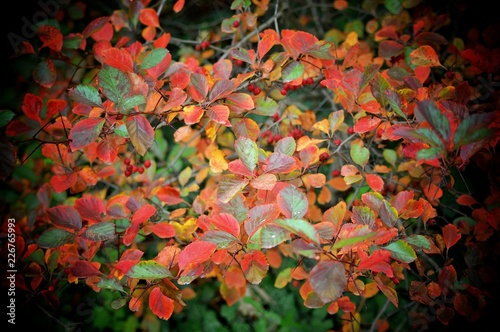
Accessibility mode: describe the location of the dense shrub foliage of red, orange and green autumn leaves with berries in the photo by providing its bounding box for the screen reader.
[0,0,500,331]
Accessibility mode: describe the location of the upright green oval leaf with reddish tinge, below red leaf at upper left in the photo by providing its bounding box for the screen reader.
[97,66,130,104]
